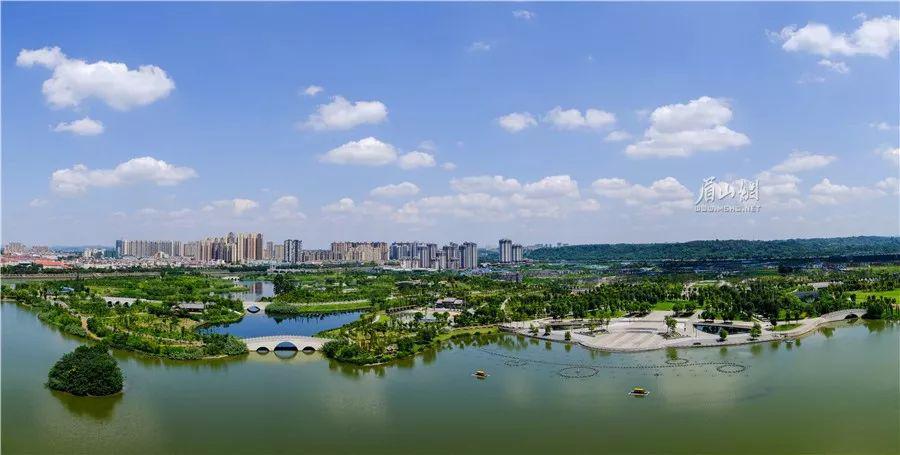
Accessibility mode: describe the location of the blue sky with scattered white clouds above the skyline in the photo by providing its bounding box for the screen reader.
[2,3,900,247]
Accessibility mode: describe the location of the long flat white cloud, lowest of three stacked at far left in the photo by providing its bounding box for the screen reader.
[50,156,197,195]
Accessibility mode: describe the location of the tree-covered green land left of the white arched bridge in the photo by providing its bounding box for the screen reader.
[2,273,247,360]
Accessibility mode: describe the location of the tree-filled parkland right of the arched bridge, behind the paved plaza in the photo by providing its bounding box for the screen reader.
[304,265,900,364]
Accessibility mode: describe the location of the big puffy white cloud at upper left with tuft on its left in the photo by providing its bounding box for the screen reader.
[16,47,175,111]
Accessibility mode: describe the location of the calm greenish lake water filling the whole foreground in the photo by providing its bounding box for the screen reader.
[0,303,900,454]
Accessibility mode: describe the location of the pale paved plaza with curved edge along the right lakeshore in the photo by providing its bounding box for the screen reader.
[501,308,866,352]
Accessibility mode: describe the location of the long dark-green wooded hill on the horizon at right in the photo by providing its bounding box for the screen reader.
[526,237,900,261]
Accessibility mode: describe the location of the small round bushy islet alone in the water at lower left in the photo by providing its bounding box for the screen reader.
[47,342,125,397]
